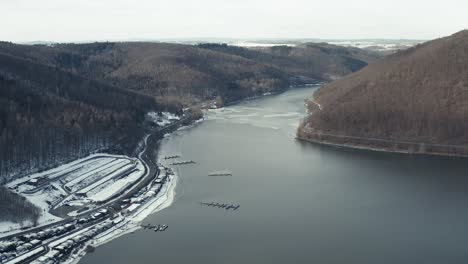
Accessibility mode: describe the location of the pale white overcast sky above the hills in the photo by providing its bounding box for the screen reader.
[0,0,468,42]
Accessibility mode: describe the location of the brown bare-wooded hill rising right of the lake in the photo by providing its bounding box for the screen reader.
[299,30,468,154]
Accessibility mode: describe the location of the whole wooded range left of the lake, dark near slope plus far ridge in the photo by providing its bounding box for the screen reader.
[0,42,378,183]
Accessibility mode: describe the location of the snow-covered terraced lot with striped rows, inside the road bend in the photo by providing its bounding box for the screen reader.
[8,154,144,225]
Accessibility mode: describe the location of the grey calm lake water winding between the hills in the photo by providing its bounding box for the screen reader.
[81,88,468,264]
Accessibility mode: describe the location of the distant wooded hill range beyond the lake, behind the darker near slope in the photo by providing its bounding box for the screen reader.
[0,43,379,104]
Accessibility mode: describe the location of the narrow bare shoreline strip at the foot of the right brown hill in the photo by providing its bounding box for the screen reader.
[295,136,468,158]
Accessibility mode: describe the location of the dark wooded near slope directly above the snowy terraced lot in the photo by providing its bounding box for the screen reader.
[0,53,158,181]
